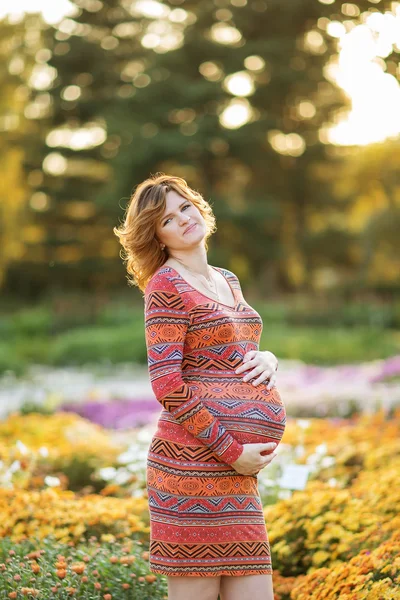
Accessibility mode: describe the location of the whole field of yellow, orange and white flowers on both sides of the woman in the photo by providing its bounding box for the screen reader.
[0,412,400,600]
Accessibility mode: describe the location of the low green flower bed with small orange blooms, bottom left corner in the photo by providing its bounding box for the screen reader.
[0,536,167,600]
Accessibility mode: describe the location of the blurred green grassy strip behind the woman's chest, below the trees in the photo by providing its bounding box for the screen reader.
[0,298,400,373]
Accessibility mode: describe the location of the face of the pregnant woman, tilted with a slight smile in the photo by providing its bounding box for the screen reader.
[156,190,207,251]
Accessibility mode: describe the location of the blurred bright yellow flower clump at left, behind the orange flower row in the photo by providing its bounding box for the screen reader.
[0,413,126,492]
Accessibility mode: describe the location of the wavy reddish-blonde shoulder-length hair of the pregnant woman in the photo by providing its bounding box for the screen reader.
[113,173,217,292]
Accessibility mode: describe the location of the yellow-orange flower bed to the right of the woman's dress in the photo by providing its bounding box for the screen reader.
[264,413,400,600]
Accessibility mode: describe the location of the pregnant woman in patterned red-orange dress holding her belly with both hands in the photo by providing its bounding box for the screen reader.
[114,174,286,600]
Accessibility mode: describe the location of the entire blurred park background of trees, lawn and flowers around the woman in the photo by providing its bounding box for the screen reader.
[0,0,400,600]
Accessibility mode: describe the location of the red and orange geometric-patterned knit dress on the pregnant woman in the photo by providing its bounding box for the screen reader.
[145,265,286,577]
